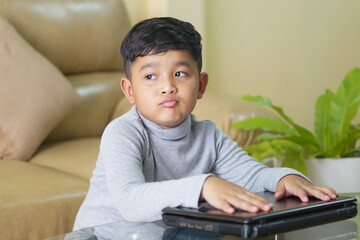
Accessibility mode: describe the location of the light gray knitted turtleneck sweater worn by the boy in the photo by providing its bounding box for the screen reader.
[74,107,301,230]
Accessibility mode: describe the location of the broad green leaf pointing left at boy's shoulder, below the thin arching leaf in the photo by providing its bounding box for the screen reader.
[231,117,295,135]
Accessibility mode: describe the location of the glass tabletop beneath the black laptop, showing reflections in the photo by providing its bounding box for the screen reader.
[47,193,360,240]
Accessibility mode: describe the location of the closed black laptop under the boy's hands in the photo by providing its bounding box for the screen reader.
[162,192,357,238]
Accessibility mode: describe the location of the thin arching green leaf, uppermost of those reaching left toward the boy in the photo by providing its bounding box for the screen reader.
[243,95,318,145]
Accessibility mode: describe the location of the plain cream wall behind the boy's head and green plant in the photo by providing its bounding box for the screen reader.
[125,0,360,130]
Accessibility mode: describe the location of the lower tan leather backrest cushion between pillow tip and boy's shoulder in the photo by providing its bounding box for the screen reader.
[46,71,124,141]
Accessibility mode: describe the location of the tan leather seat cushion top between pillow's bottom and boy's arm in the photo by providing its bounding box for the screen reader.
[30,137,100,179]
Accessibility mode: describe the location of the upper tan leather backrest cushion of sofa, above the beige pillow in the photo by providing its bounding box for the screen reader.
[0,0,130,74]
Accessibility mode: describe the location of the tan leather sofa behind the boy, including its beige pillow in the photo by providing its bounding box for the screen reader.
[0,0,268,239]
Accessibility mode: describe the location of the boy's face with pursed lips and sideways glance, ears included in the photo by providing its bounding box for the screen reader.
[121,50,208,128]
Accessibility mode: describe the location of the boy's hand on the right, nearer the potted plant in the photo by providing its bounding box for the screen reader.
[275,175,338,202]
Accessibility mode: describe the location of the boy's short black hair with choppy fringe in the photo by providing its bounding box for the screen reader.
[121,17,202,79]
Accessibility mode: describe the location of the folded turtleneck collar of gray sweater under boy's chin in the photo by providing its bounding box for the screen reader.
[136,109,191,141]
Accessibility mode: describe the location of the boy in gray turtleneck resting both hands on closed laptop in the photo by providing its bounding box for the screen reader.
[74,18,336,230]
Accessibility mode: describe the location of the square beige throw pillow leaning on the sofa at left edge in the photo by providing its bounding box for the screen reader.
[0,16,80,160]
